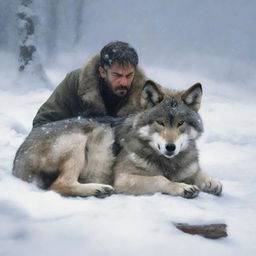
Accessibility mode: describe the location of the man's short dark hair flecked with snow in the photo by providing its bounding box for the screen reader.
[100,41,139,70]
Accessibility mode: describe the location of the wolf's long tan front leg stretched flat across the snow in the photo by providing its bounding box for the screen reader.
[114,173,199,198]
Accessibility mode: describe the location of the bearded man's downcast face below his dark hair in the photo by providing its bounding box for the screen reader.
[99,63,135,97]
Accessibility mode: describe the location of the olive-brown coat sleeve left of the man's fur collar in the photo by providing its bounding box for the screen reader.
[33,70,80,128]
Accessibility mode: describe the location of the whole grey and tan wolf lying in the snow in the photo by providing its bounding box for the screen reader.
[13,82,222,198]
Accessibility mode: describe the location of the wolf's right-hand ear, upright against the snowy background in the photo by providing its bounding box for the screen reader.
[181,83,203,111]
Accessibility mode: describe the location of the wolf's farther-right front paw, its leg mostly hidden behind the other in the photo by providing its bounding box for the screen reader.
[193,171,222,196]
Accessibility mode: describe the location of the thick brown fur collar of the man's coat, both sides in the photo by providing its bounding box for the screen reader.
[78,54,151,116]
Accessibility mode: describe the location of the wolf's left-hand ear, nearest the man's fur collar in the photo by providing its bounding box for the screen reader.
[140,80,164,109]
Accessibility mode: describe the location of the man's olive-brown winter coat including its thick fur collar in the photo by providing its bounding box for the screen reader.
[33,55,155,127]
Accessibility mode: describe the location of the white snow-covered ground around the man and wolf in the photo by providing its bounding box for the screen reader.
[0,62,256,256]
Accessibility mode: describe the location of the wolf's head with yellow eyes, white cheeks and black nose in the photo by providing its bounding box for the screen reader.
[133,83,203,158]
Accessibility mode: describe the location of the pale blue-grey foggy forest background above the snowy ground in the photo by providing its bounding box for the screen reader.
[0,0,256,93]
